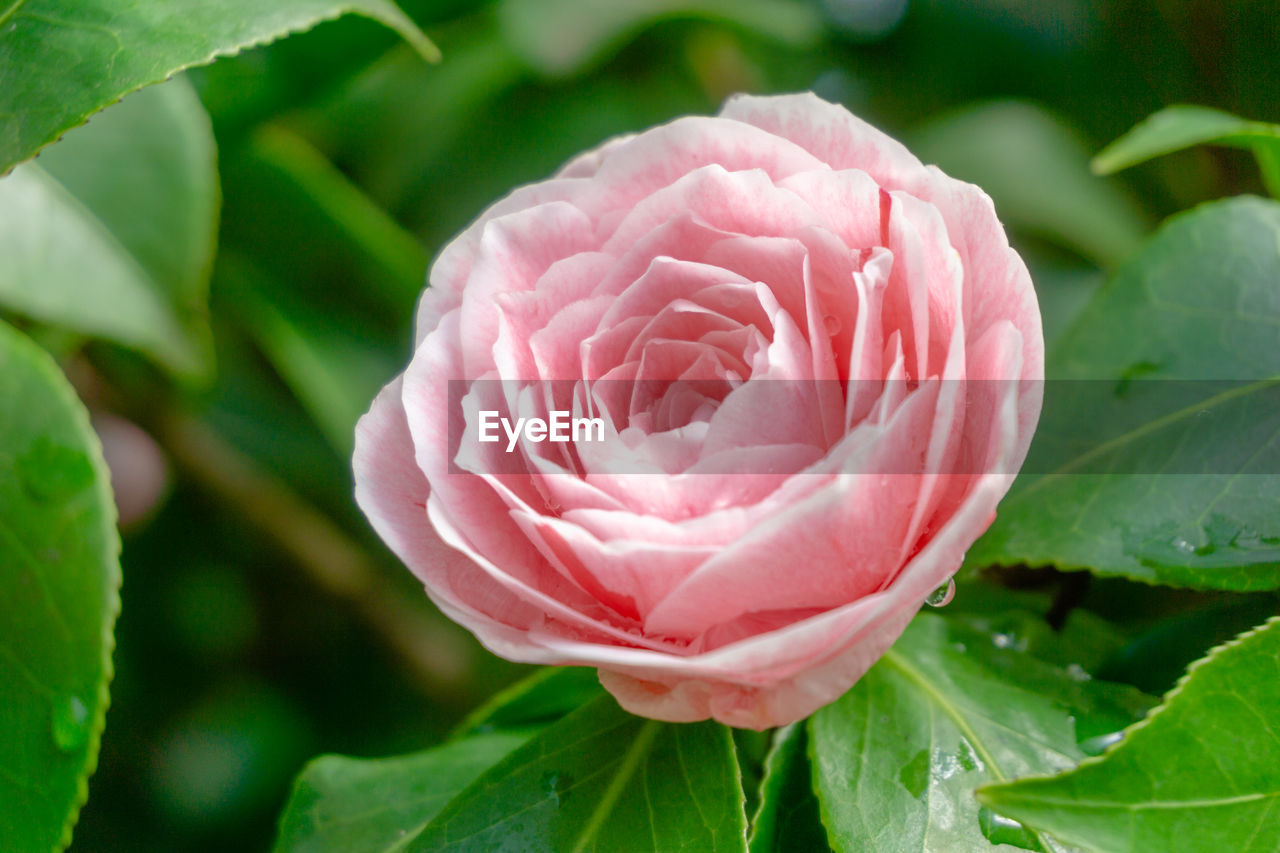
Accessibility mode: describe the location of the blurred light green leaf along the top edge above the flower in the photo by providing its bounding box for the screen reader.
[498,0,823,77]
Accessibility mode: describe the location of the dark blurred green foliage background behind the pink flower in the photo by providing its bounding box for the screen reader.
[70,0,1280,853]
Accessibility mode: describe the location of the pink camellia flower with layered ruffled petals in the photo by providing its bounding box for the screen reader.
[355,95,1043,729]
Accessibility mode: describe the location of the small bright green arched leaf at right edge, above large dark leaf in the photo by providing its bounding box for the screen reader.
[1093,104,1280,197]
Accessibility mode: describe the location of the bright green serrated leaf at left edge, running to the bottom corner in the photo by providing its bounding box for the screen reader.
[0,323,120,853]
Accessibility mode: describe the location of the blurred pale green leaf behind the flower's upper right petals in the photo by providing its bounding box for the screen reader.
[910,101,1152,268]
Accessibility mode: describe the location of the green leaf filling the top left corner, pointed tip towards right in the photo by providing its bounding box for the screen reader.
[0,0,438,174]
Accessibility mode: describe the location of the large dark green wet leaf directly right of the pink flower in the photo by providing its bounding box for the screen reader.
[969,197,1280,590]
